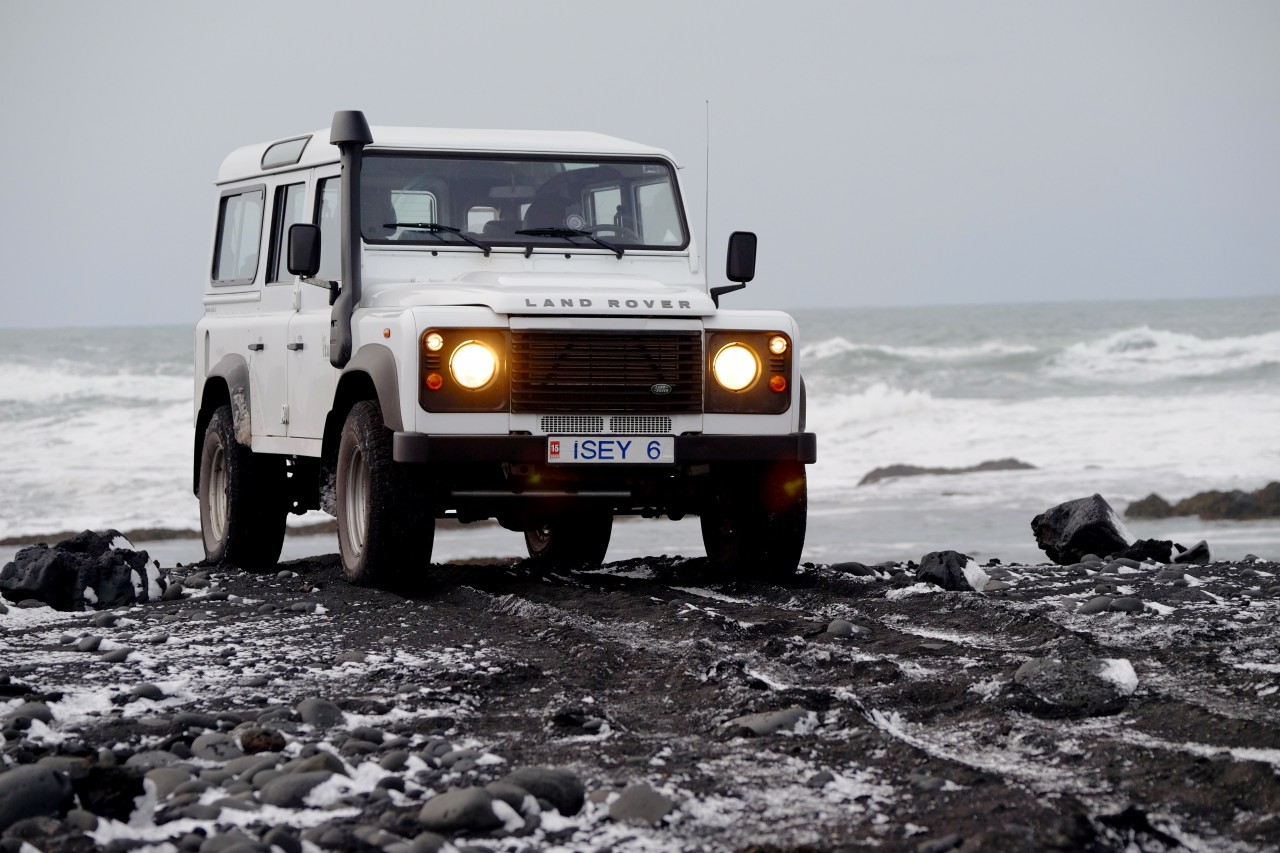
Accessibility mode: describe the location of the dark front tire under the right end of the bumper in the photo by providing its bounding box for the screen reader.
[700,462,809,583]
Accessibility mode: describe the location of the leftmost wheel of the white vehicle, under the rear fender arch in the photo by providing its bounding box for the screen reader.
[200,406,289,569]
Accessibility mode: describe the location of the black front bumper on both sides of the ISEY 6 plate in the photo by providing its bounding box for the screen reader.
[392,433,818,467]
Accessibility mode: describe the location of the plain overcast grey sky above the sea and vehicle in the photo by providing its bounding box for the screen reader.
[0,0,1280,327]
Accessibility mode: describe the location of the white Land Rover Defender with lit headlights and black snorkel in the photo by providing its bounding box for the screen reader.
[195,111,817,587]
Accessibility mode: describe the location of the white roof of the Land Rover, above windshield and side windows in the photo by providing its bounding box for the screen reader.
[218,126,675,183]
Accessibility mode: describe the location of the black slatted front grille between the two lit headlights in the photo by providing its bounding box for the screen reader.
[511,330,703,414]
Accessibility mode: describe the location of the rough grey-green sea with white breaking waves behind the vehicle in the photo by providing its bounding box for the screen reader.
[0,297,1280,562]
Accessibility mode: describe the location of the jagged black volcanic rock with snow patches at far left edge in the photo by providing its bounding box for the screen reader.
[0,530,165,610]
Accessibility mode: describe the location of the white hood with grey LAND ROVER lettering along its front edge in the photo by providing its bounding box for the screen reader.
[362,273,716,316]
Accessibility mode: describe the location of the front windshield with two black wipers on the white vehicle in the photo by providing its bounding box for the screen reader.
[360,151,689,251]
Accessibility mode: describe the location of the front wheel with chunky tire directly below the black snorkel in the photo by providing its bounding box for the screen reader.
[334,400,435,589]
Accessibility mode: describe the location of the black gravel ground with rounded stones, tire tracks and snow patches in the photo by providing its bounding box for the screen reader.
[0,548,1280,853]
